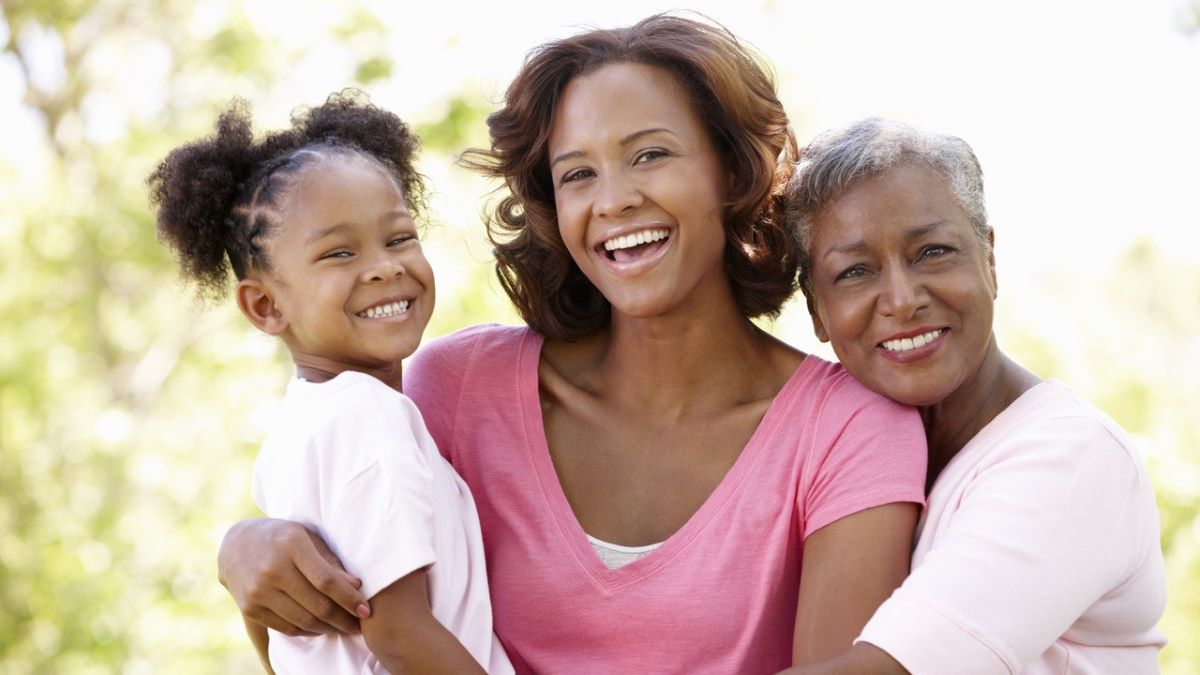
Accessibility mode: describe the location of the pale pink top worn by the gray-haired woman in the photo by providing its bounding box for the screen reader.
[859,382,1166,675]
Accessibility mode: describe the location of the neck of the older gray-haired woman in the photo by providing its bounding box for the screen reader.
[920,335,1039,491]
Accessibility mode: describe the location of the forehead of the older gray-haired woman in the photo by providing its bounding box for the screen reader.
[812,163,971,246]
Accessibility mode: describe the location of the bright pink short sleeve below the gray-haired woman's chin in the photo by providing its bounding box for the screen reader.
[800,372,928,538]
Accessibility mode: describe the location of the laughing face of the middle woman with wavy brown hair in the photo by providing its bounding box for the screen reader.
[550,64,732,317]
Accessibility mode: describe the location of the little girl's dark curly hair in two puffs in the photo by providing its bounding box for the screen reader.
[148,90,425,298]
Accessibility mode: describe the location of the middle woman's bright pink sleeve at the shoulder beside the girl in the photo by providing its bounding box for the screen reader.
[404,327,486,464]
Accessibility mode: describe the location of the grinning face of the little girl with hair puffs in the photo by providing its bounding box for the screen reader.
[246,157,434,372]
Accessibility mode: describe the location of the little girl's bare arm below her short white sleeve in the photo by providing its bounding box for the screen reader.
[362,569,484,675]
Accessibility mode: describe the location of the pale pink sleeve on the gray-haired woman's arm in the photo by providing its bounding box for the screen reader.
[859,417,1144,675]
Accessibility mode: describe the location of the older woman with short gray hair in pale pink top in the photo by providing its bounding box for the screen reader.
[788,119,1165,675]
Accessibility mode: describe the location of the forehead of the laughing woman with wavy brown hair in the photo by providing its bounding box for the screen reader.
[550,62,703,154]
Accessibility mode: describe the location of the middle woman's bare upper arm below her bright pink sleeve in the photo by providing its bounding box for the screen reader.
[792,502,919,665]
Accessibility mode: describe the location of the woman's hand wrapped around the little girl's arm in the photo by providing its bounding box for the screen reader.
[217,519,371,635]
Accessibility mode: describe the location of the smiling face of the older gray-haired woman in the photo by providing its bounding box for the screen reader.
[809,165,996,406]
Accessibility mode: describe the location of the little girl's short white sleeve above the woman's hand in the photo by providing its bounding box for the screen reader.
[322,384,436,598]
